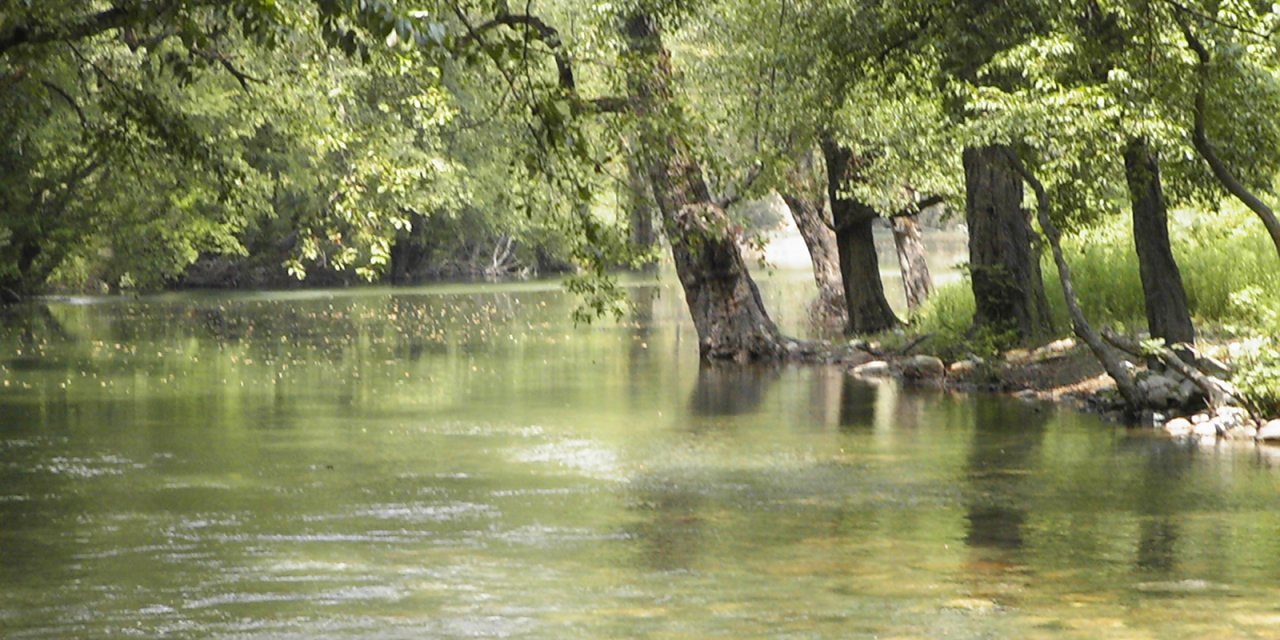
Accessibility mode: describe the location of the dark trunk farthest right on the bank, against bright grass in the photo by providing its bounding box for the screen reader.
[1124,138,1196,346]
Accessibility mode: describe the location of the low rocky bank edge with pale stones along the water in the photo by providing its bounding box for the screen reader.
[849,339,1280,445]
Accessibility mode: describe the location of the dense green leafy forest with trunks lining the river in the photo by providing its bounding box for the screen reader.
[0,0,1280,411]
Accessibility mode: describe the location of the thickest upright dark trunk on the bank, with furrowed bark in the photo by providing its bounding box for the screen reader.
[964,145,1046,340]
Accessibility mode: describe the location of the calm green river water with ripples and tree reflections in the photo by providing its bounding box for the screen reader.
[0,276,1280,639]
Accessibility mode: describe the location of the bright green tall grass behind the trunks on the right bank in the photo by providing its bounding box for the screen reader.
[913,206,1280,415]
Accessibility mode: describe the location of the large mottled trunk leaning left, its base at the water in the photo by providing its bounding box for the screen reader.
[625,13,786,361]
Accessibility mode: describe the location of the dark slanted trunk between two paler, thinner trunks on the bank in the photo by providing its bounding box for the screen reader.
[822,138,901,334]
